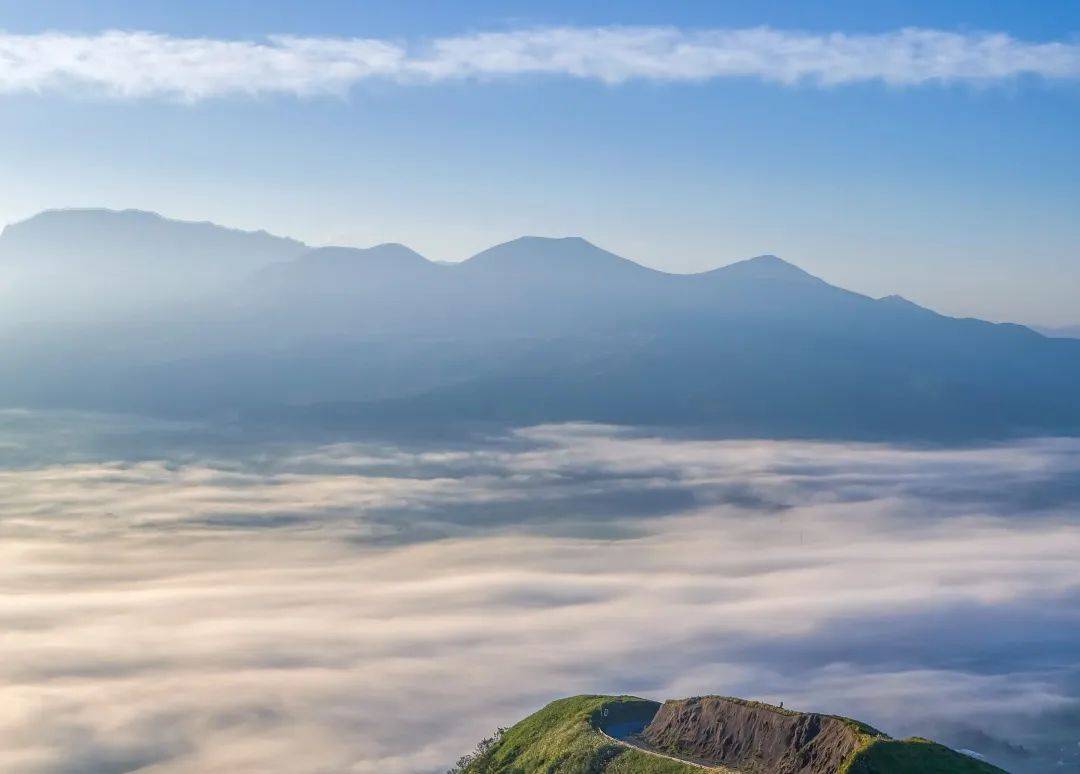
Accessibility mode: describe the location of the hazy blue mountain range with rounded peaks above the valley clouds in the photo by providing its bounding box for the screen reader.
[0,211,1080,440]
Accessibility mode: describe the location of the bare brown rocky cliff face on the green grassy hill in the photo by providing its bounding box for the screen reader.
[642,696,873,774]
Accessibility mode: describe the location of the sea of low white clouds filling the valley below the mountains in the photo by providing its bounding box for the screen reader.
[0,417,1080,772]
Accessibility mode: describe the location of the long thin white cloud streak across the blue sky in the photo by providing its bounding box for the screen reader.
[0,27,1080,100]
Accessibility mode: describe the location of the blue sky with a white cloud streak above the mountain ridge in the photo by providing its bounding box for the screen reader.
[0,0,1080,325]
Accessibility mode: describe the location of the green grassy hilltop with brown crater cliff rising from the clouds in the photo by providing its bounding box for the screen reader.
[459,696,1002,774]
